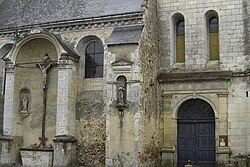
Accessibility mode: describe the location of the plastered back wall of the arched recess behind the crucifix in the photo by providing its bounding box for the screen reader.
[13,38,58,148]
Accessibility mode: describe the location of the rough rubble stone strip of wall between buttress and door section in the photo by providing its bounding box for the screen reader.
[139,0,162,166]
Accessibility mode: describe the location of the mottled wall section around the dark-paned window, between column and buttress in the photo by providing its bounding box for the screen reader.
[60,28,113,166]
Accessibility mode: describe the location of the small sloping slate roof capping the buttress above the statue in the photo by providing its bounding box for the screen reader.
[108,25,143,45]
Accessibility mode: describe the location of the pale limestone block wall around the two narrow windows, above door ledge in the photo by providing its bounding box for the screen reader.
[158,0,245,71]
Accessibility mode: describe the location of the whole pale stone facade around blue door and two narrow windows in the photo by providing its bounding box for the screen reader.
[158,0,249,166]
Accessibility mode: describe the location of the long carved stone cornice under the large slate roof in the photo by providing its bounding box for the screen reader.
[0,12,143,38]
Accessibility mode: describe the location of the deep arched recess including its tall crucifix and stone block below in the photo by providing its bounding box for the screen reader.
[13,38,58,167]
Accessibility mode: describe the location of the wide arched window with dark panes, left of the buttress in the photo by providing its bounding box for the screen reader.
[85,41,103,78]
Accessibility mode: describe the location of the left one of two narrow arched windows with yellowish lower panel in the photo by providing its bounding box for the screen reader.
[176,18,185,63]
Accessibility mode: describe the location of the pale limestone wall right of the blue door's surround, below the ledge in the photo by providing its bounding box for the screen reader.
[228,77,250,155]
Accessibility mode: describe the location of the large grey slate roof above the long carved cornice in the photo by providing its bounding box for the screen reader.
[0,0,143,29]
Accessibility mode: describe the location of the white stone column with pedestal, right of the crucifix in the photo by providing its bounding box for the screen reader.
[54,60,76,167]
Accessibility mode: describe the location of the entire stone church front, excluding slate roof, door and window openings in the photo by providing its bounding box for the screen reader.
[0,0,250,167]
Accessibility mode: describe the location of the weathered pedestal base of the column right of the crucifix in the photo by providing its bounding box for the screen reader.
[53,135,77,167]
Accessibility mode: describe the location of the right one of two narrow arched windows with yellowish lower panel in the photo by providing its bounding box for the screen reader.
[208,16,219,60]
